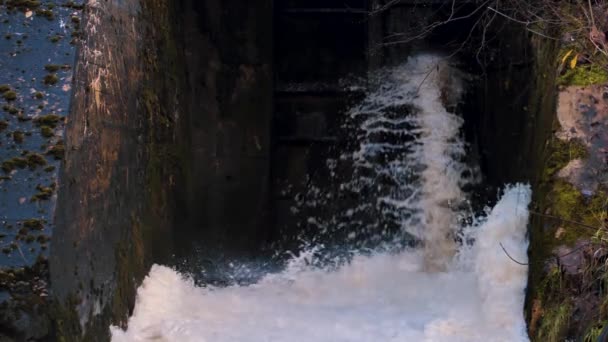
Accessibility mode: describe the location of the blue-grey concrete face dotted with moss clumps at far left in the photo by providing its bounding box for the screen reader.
[0,1,82,341]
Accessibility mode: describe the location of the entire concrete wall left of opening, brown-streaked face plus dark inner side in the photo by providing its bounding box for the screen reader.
[50,0,273,340]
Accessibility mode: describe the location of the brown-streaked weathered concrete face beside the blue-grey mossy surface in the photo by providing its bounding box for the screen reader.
[50,0,183,340]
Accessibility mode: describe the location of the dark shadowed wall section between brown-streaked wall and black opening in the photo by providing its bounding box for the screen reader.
[178,0,273,254]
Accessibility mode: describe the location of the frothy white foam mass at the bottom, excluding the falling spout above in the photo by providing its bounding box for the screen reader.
[112,185,530,342]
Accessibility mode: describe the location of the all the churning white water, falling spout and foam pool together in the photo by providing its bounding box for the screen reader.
[111,55,530,342]
